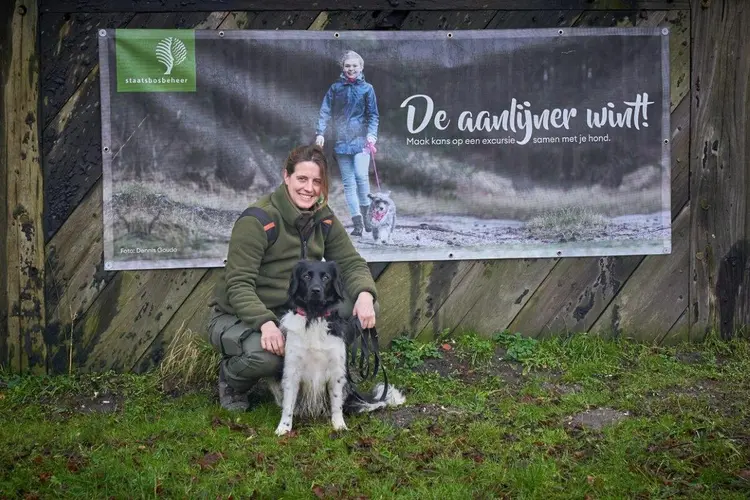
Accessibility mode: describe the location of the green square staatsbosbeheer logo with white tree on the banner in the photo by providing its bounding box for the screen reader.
[115,29,195,92]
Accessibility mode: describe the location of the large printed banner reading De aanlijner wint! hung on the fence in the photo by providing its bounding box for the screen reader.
[99,28,671,269]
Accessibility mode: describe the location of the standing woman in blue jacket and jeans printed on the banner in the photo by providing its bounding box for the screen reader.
[315,50,379,236]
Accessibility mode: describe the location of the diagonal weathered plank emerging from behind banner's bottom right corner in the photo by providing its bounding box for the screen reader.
[590,205,690,342]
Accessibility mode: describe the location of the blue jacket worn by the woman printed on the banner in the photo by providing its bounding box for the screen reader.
[316,73,380,155]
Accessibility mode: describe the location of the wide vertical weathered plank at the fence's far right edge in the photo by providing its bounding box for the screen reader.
[690,0,750,339]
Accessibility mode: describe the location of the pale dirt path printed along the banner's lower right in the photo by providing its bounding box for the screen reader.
[345,213,669,248]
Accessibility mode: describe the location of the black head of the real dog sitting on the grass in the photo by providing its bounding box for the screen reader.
[288,260,344,318]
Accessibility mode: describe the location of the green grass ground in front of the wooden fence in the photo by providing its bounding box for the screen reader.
[0,332,750,499]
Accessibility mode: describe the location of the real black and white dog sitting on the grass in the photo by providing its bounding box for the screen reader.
[269,260,405,436]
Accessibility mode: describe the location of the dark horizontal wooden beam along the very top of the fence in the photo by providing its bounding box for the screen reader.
[40,0,689,12]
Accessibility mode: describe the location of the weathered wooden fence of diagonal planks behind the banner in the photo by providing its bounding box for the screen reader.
[0,0,750,372]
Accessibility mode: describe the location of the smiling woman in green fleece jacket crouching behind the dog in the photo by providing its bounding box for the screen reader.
[207,145,379,411]
